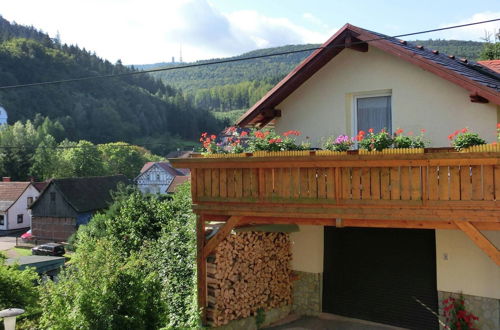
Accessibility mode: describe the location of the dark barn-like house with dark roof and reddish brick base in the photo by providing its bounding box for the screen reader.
[31,175,129,241]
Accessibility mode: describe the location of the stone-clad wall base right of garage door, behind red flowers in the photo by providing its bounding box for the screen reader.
[438,291,500,330]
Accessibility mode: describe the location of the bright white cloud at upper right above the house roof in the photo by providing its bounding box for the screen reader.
[424,12,500,41]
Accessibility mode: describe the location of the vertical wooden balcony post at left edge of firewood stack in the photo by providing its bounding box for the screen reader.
[196,215,207,325]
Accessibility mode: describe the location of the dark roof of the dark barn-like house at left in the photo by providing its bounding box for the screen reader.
[50,175,129,213]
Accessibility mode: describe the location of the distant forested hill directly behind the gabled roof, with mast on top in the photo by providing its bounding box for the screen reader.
[136,40,483,117]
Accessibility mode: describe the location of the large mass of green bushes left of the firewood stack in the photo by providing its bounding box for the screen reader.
[40,184,199,329]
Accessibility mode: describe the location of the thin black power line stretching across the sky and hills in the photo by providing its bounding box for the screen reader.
[0,18,500,90]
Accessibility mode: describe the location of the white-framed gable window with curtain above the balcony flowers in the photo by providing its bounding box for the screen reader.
[354,95,392,134]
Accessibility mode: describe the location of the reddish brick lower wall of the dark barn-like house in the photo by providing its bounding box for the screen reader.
[31,217,76,242]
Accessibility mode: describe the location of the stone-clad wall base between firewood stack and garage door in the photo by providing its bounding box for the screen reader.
[292,271,323,315]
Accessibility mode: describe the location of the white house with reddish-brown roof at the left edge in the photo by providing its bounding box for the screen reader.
[0,178,39,235]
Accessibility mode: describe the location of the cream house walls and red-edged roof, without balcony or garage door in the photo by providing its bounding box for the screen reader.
[237,24,500,329]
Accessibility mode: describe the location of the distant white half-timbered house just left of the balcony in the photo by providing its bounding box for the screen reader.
[134,162,189,194]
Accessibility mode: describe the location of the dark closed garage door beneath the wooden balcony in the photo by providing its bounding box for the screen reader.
[323,227,438,329]
